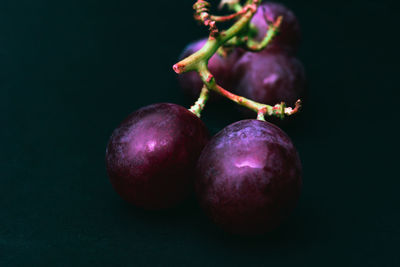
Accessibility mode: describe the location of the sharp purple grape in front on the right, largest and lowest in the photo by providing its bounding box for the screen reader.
[196,120,301,235]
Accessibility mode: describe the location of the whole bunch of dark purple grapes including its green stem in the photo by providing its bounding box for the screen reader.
[106,0,304,235]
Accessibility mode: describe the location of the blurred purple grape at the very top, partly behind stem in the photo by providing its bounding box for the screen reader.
[251,2,301,53]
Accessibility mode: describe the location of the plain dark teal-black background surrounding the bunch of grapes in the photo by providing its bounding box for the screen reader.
[0,0,400,266]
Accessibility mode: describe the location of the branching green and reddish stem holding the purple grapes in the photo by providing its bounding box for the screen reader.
[173,0,301,120]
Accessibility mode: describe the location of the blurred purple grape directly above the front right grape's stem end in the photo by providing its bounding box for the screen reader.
[234,52,305,111]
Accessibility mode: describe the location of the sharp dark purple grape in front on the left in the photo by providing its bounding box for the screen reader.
[106,103,209,209]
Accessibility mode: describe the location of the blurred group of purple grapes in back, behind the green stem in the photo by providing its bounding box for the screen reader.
[178,2,306,115]
